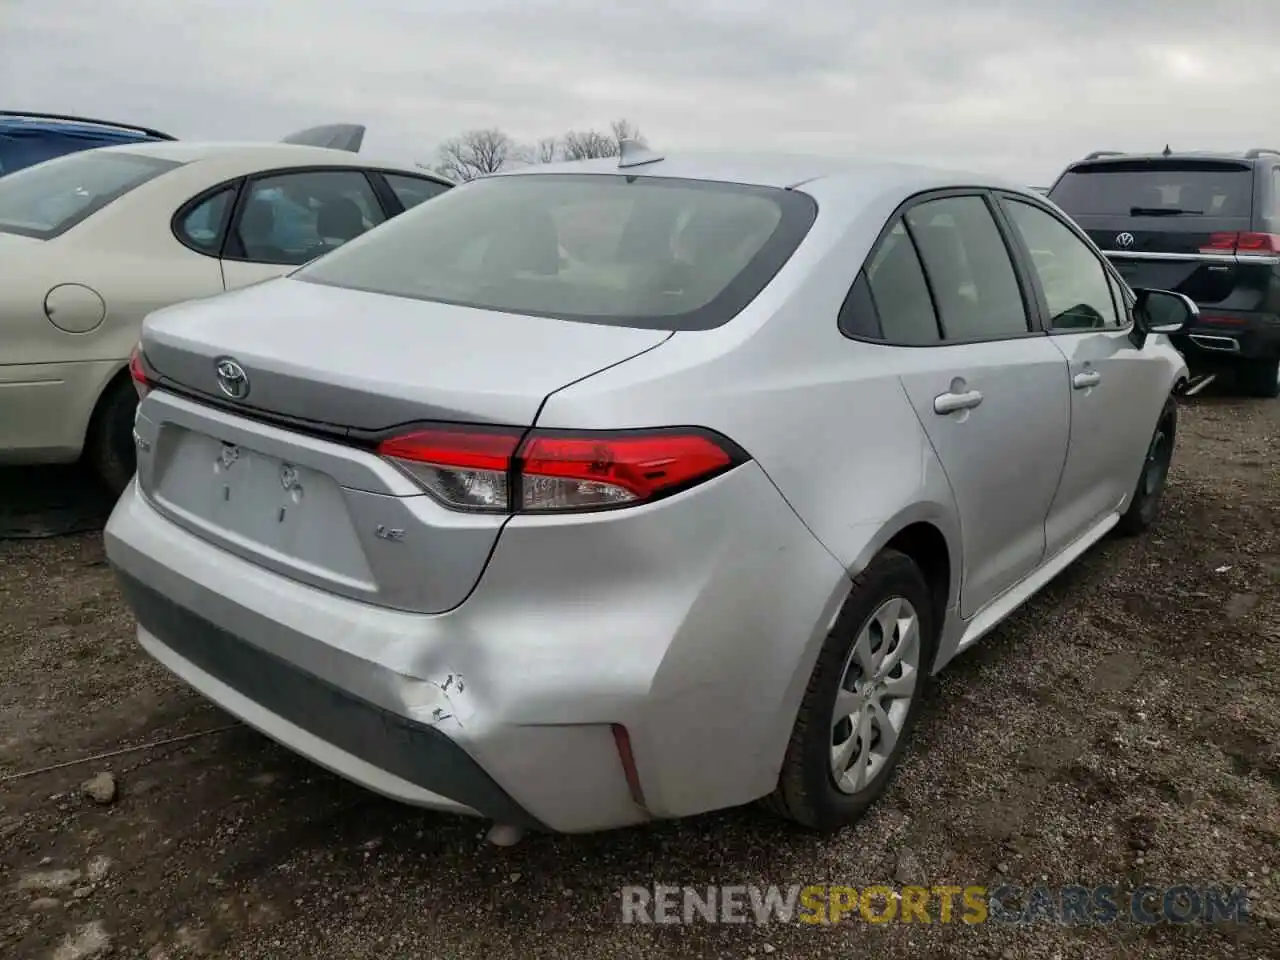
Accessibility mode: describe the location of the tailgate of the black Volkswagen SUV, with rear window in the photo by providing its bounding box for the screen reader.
[1050,157,1271,311]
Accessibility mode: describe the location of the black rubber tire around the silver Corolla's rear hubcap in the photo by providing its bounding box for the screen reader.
[763,550,937,832]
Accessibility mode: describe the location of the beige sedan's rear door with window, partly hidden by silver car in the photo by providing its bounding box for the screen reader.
[221,166,388,291]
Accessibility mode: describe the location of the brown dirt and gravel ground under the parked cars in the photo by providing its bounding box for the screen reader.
[0,397,1280,960]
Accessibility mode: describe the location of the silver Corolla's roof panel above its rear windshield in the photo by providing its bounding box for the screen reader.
[492,152,1028,192]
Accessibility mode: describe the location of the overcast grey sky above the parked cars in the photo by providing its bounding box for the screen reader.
[0,0,1280,183]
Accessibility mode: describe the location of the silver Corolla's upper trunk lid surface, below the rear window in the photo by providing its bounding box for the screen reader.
[142,278,671,434]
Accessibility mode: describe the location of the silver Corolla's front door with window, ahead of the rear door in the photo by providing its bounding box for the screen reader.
[1001,196,1167,556]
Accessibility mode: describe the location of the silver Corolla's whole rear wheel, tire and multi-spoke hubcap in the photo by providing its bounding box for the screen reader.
[765,550,934,832]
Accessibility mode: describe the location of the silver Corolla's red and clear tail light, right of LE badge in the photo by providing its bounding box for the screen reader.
[378,426,748,513]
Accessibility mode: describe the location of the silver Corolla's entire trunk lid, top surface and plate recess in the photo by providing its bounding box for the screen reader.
[136,273,671,613]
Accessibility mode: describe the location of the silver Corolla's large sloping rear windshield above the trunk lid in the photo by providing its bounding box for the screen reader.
[293,174,817,330]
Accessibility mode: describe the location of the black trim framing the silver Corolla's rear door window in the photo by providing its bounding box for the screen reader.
[836,187,1046,349]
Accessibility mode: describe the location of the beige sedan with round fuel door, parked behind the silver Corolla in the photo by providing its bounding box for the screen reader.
[0,141,451,492]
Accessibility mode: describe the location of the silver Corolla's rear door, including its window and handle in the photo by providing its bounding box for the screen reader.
[846,193,1070,618]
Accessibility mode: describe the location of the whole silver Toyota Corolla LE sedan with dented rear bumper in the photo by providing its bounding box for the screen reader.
[106,145,1194,832]
